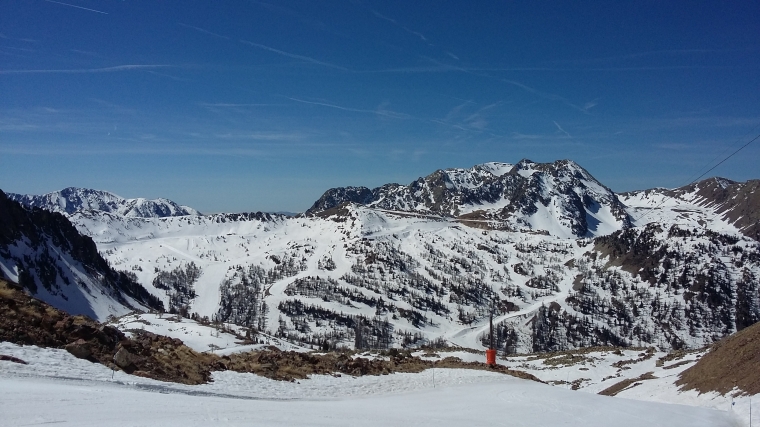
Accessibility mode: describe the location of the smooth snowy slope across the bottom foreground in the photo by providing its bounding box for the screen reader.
[0,343,743,427]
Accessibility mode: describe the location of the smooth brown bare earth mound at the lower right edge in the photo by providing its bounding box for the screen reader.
[676,323,760,395]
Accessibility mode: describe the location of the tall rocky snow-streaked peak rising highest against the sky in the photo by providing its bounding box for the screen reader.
[307,160,631,241]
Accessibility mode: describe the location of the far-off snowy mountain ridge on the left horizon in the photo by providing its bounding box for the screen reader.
[8,187,200,218]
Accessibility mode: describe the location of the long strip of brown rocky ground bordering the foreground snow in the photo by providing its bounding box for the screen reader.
[0,280,541,384]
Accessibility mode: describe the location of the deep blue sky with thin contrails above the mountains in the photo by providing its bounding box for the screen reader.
[0,0,760,212]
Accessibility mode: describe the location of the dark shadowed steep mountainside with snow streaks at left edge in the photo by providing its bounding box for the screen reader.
[0,191,162,320]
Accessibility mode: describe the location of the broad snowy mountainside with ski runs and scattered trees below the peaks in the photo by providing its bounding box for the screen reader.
[59,205,760,352]
